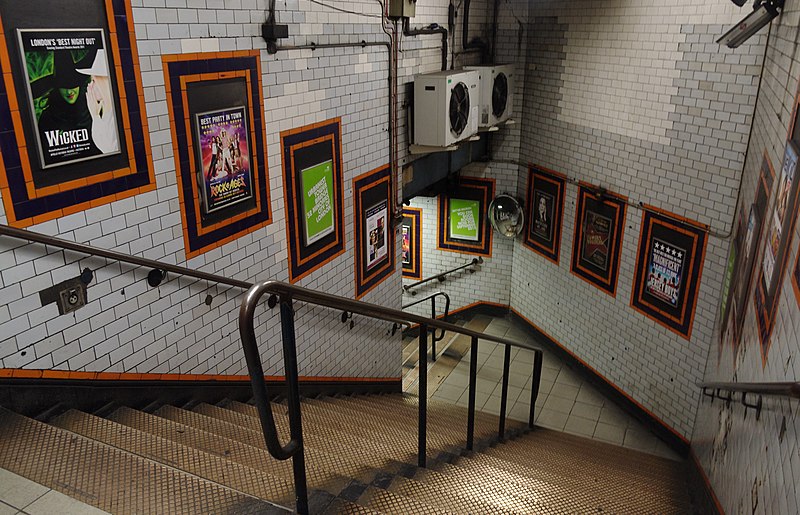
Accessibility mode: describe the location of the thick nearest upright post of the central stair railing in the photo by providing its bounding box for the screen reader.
[281,299,308,514]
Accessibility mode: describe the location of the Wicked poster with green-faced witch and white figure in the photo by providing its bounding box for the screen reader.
[17,28,120,169]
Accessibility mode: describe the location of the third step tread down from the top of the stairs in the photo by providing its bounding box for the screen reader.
[108,407,351,496]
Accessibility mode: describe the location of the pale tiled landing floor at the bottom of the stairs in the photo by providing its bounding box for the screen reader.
[412,318,680,460]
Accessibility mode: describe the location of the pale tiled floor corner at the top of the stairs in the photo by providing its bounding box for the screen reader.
[0,469,106,515]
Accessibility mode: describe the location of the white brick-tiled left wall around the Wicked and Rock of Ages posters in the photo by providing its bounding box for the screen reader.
[0,0,404,377]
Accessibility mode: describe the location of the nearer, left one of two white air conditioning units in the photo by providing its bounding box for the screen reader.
[414,70,480,147]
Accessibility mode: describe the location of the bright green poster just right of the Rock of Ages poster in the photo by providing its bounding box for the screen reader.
[300,160,335,246]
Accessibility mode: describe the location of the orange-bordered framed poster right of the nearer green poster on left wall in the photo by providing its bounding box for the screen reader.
[353,165,395,299]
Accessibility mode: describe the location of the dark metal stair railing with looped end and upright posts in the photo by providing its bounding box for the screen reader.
[239,281,543,513]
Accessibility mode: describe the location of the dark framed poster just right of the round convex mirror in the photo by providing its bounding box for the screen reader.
[522,166,566,264]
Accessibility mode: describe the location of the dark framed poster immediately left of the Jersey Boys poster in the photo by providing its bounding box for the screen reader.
[571,184,627,297]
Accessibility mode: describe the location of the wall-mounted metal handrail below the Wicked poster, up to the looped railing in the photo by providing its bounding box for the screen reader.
[0,224,253,290]
